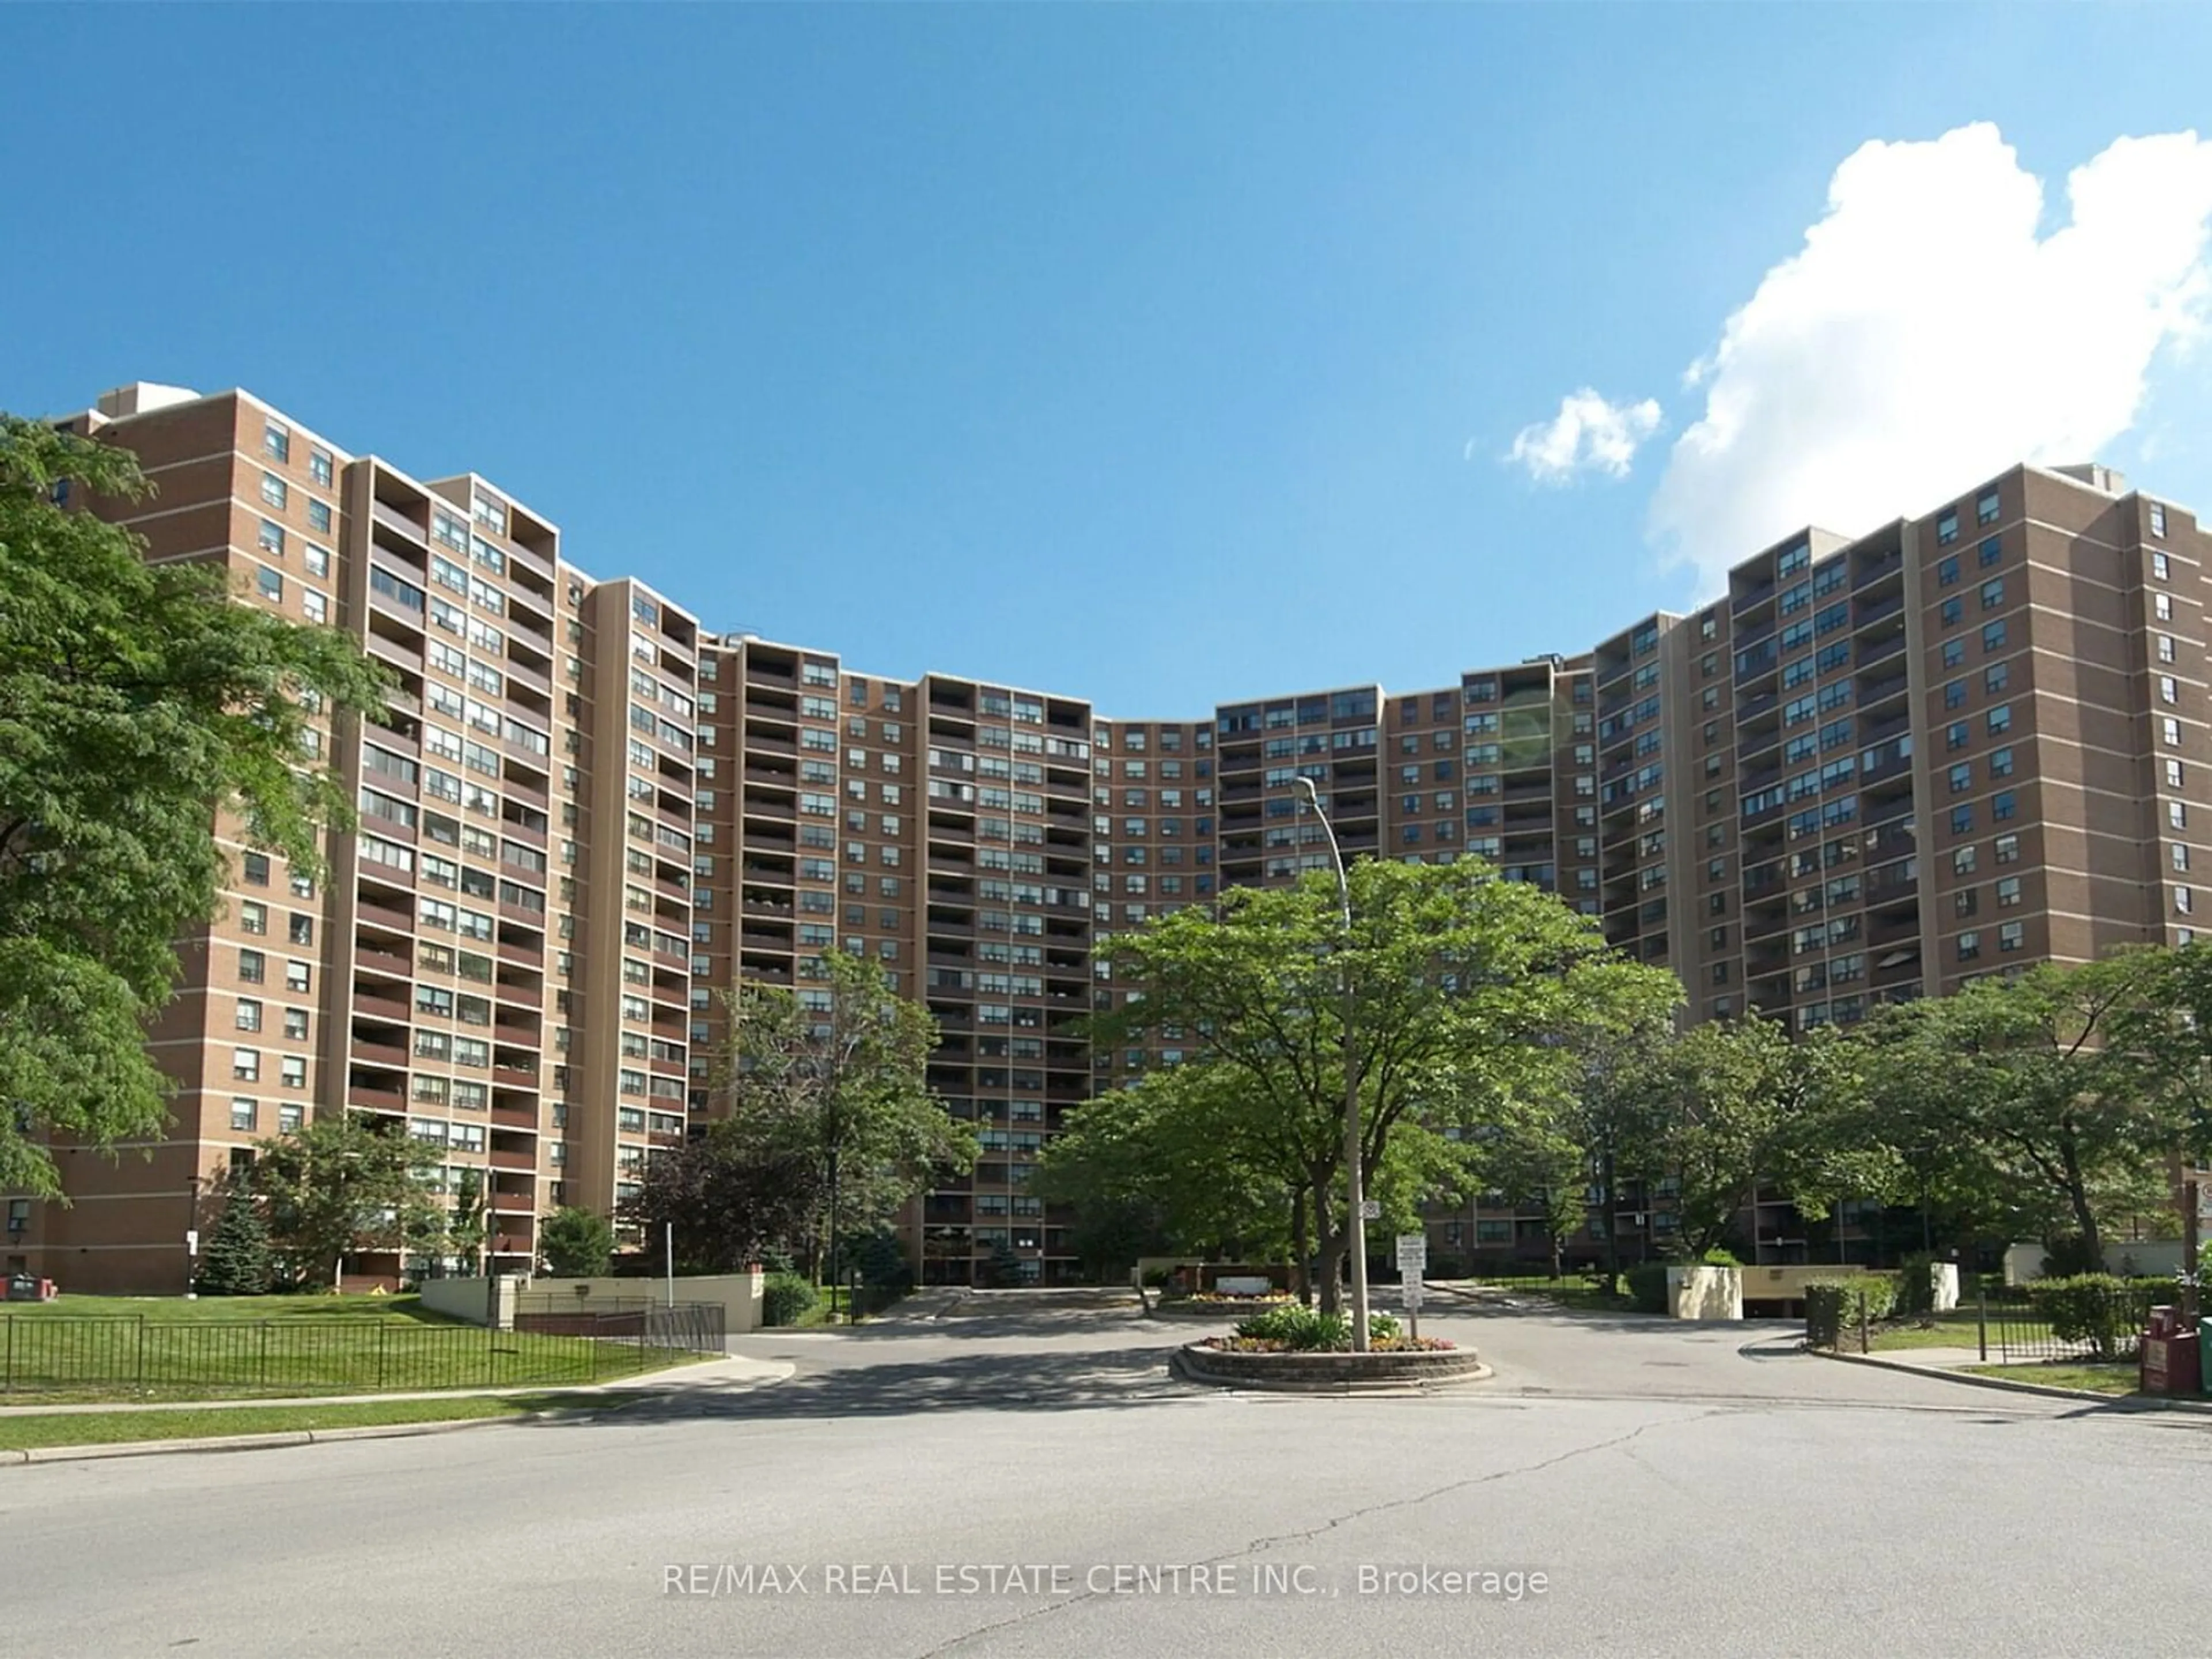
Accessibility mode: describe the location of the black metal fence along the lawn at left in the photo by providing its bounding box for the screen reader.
[0,1303,724,1396]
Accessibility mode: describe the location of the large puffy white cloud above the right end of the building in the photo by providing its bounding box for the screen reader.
[1654,124,2212,590]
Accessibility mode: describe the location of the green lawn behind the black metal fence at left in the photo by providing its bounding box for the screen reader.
[0,1296,692,1403]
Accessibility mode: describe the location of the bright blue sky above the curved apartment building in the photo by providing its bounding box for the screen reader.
[0,5,2212,717]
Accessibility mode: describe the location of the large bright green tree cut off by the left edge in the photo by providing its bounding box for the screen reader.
[0,416,380,1196]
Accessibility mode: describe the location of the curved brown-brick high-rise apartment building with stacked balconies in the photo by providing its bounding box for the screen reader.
[0,385,2212,1290]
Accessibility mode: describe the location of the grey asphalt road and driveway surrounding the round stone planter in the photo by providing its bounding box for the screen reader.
[0,1298,2212,1659]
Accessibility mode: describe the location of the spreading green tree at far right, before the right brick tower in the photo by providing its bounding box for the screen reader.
[1869,949,2201,1270]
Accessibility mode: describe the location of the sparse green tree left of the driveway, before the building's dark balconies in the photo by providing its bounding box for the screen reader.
[721,951,975,1283]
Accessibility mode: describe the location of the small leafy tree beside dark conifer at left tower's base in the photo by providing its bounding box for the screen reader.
[248,1113,445,1285]
